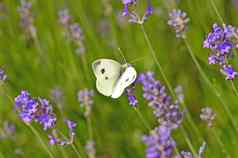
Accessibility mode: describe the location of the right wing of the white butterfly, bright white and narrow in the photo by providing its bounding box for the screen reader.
[111,66,137,98]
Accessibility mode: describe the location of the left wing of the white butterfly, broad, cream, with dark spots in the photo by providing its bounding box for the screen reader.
[92,59,121,96]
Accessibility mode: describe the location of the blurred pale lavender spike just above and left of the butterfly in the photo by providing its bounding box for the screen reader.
[59,9,85,55]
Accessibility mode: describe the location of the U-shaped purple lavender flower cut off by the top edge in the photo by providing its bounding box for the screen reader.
[122,0,153,24]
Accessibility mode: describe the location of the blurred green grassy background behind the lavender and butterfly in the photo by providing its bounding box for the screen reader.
[0,0,238,158]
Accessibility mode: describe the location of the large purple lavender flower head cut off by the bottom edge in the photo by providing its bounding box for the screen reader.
[143,126,176,158]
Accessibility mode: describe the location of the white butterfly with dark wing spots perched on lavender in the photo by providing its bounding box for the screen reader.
[92,59,137,98]
